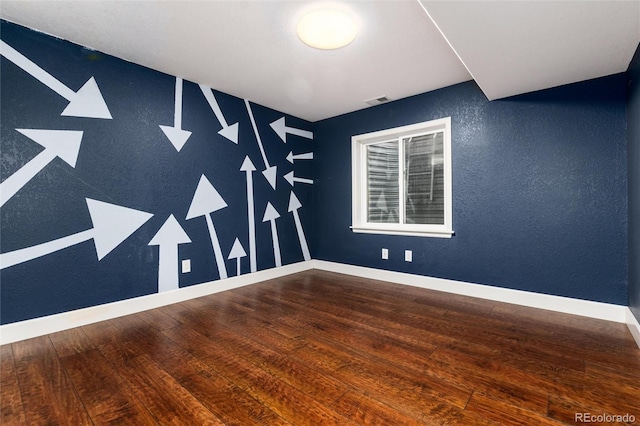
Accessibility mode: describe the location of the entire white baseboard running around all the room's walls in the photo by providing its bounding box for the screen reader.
[0,260,640,347]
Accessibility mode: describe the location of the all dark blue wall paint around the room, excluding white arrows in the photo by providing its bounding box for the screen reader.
[0,21,640,324]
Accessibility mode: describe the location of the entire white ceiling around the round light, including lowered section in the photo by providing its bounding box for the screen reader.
[0,0,640,121]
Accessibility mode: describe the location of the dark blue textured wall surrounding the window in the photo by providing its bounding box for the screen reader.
[314,74,628,305]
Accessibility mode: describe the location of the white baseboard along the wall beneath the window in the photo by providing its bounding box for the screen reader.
[312,260,628,323]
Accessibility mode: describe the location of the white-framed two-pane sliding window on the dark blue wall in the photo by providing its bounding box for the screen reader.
[351,117,453,238]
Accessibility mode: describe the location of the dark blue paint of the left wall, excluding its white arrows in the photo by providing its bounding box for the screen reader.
[0,21,314,324]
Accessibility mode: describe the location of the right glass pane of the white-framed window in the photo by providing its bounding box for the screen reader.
[402,132,444,225]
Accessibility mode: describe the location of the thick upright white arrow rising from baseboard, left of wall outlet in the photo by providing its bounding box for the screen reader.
[149,215,191,293]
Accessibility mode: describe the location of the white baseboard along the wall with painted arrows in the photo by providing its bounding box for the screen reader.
[0,261,313,345]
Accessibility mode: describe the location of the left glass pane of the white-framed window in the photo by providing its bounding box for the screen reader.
[367,141,400,223]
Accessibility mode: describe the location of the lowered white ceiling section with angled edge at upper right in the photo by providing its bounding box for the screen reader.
[422,0,640,99]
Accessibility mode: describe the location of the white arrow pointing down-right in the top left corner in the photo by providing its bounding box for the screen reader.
[0,40,111,119]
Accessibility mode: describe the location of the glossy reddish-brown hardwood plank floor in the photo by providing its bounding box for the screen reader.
[0,270,640,426]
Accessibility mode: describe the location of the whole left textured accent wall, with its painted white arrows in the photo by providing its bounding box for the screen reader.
[0,22,313,323]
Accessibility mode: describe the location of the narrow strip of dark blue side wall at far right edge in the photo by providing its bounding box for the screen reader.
[627,45,640,321]
